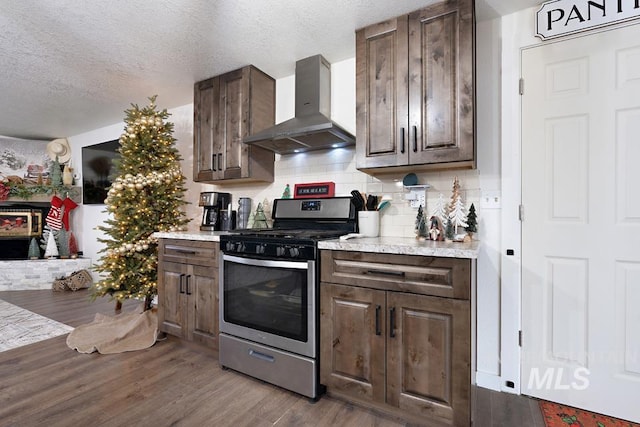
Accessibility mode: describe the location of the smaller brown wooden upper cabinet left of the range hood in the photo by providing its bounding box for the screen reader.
[193,66,276,184]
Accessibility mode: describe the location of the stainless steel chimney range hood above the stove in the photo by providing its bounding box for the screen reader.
[243,55,355,154]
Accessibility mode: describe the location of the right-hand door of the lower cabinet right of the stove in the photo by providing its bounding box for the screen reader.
[387,292,471,425]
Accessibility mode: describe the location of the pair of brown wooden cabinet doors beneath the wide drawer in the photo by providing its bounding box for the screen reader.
[320,282,471,426]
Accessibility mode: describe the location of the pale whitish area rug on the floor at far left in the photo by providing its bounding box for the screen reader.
[0,300,73,352]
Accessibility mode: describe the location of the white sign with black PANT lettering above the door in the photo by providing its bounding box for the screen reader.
[536,0,640,40]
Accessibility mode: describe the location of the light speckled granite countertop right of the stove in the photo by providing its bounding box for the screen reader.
[318,237,480,259]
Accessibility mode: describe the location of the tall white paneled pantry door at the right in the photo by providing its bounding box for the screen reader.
[521,25,640,422]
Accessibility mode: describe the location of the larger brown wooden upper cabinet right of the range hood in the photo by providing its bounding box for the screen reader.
[356,0,475,173]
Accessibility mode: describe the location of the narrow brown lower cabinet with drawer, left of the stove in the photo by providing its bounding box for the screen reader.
[158,239,218,349]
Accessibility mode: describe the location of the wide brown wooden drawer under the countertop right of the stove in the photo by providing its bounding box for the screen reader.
[320,251,471,300]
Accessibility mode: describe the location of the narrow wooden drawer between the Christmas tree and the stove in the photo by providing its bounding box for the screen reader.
[158,239,219,267]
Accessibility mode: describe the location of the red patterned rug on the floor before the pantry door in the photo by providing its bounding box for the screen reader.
[540,400,640,427]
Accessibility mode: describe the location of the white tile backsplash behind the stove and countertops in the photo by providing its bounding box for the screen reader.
[181,138,480,237]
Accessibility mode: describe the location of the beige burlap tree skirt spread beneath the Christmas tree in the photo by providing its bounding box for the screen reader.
[67,309,158,354]
